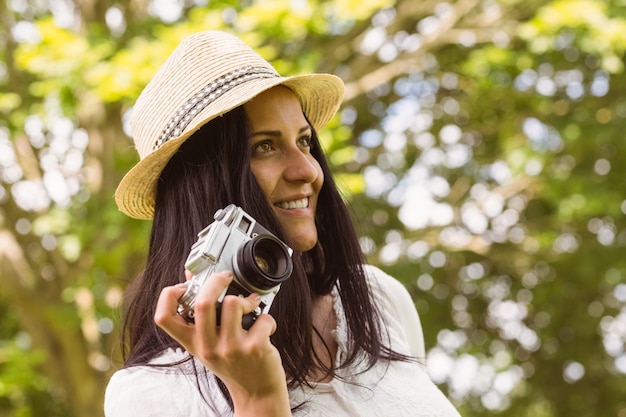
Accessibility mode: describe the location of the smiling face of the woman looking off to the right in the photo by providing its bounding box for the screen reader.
[244,86,324,251]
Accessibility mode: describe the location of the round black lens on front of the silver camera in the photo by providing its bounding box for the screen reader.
[233,235,293,292]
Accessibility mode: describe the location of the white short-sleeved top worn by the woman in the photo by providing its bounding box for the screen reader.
[104,266,460,417]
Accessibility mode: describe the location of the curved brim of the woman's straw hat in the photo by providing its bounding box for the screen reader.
[115,74,345,220]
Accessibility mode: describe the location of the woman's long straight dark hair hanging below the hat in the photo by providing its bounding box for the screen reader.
[123,107,406,406]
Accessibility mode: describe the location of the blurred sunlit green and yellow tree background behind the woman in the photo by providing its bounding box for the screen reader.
[0,0,626,417]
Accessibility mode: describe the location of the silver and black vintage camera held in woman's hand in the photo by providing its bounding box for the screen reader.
[178,204,293,330]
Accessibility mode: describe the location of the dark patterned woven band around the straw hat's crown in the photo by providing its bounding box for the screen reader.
[152,66,279,151]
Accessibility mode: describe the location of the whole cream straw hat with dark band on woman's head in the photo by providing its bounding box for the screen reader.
[115,31,345,219]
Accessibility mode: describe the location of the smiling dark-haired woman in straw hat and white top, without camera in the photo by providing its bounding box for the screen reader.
[105,31,458,417]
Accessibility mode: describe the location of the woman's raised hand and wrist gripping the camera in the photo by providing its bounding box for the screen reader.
[154,271,291,416]
